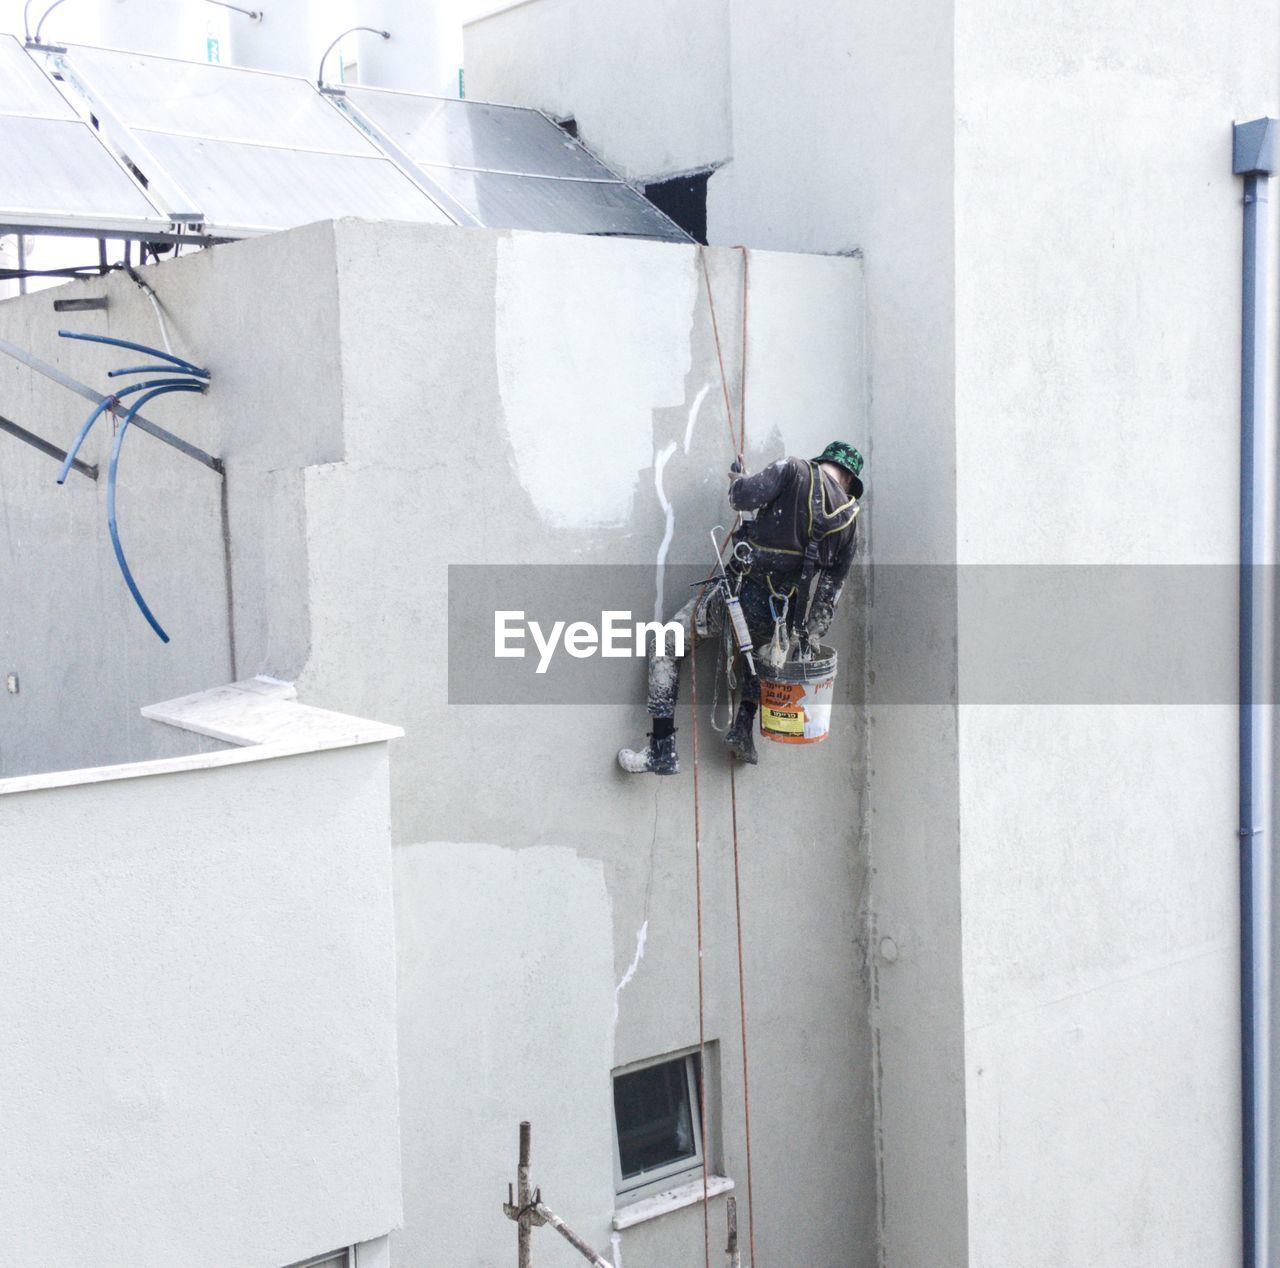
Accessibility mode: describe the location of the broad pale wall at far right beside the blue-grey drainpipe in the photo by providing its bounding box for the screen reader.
[956,3,1280,1265]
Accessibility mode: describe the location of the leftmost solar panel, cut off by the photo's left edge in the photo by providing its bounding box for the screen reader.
[0,36,172,237]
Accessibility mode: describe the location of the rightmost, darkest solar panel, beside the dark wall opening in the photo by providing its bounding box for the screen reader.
[338,87,690,242]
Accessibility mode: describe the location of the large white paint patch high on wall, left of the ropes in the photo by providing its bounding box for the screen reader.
[495,233,696,527]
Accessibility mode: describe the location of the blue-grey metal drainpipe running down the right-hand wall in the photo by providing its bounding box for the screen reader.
[1231,118,1276,1268]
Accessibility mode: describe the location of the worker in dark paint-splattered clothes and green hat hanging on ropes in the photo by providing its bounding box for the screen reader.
[618,440,863,775]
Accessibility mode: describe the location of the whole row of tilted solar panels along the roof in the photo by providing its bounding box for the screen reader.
[0,36,690,242]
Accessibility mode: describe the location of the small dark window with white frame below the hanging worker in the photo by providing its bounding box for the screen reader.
[613,1053,703,1194]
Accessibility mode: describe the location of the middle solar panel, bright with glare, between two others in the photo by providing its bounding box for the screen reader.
[55,45,452,237]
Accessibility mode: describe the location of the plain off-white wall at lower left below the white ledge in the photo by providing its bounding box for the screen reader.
[0,724,401,1268]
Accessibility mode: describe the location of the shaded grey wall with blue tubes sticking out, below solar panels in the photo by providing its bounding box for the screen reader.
[0,225,342,775]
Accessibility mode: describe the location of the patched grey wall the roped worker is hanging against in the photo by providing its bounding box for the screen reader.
[308,224,874,1265]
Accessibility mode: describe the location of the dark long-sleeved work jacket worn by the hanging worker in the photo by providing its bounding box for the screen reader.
[728,458,858,592]
